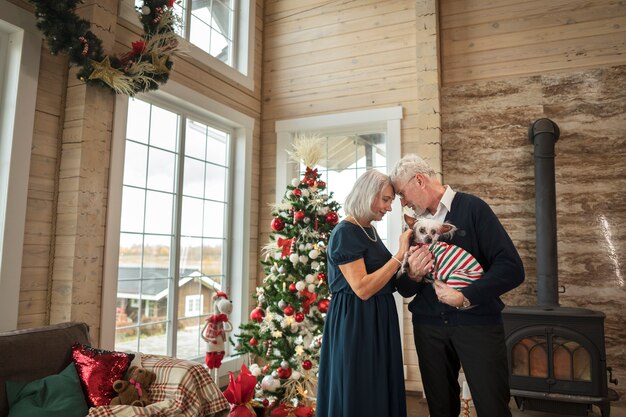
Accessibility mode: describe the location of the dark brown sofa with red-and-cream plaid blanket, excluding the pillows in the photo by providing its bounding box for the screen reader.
[0,322,229,417]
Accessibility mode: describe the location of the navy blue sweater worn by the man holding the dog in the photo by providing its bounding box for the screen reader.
[396,192,524,325]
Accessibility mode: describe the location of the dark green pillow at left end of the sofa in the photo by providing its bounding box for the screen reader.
[6,363,89,417]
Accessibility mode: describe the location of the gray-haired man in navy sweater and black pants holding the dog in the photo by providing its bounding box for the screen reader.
[391,154,524,417]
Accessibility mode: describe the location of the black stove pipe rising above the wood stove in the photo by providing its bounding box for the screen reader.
[528,119,560,309]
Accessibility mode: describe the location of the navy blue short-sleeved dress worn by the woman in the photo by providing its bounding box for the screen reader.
[315,221,406,417]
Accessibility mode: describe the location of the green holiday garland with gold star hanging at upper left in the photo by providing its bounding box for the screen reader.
[30,0,179,96]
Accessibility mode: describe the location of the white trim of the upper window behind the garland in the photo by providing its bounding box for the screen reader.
[119,0,256,91]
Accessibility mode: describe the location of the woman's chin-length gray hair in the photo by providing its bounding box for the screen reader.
[343,169,391,220]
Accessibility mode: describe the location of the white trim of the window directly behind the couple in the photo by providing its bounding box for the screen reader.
[275,106,406,358]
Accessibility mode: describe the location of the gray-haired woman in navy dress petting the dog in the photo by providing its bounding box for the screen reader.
[316,170,412,417]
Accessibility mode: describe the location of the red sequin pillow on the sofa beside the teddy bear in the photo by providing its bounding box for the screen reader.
[72,343,135,407]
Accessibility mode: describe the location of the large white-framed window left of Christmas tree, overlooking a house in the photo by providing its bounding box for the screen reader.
[102,80,253,370]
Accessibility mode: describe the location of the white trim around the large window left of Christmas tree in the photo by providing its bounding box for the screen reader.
[100,80,254,376]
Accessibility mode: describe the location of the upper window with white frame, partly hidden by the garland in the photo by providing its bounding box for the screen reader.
[120,0,255,90]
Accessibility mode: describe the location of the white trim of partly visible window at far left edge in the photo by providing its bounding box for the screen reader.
[0,0,42,331]
